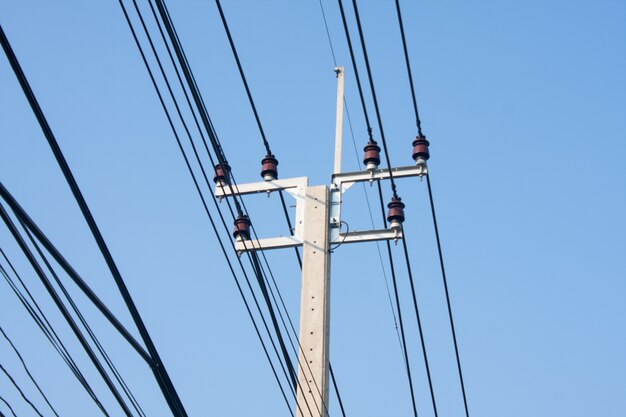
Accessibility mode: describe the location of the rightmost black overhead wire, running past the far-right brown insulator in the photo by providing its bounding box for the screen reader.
[395,0,469,417]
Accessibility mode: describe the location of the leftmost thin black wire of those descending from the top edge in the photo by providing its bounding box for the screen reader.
[120,2,300,415]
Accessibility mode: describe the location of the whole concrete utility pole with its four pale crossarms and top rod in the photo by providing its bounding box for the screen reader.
[215,67,427,417]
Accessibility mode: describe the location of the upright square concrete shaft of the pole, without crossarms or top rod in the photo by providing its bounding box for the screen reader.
[297,186,330,417]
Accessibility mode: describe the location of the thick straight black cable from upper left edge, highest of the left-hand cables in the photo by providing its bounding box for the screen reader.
[0,26,187,417]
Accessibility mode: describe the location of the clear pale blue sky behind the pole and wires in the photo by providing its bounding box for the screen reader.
[0,0,626,417]
